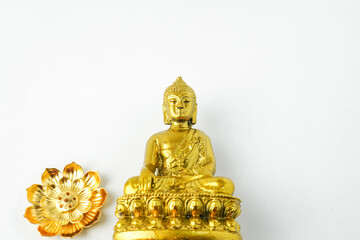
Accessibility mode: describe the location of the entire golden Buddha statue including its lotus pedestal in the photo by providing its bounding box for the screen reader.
[114,77,241,240]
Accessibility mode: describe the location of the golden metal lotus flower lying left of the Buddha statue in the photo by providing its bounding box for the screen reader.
[24,162,107,237]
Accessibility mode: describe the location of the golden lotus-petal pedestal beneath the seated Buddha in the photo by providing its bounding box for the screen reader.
[113,192,242,240]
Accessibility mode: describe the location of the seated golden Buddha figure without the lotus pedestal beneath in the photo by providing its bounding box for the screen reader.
[124,77,234,195]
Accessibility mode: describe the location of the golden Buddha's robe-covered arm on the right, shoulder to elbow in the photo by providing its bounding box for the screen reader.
[193,134,216,176]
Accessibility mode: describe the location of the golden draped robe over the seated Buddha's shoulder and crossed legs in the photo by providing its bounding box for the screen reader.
[124,129,234,195]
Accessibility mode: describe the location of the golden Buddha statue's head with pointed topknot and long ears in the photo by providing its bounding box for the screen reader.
[163,77,197,125]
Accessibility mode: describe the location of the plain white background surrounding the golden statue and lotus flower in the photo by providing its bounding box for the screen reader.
[0,0,360,240]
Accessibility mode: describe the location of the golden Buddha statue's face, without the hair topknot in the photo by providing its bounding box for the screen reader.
[164,92,196,122]
